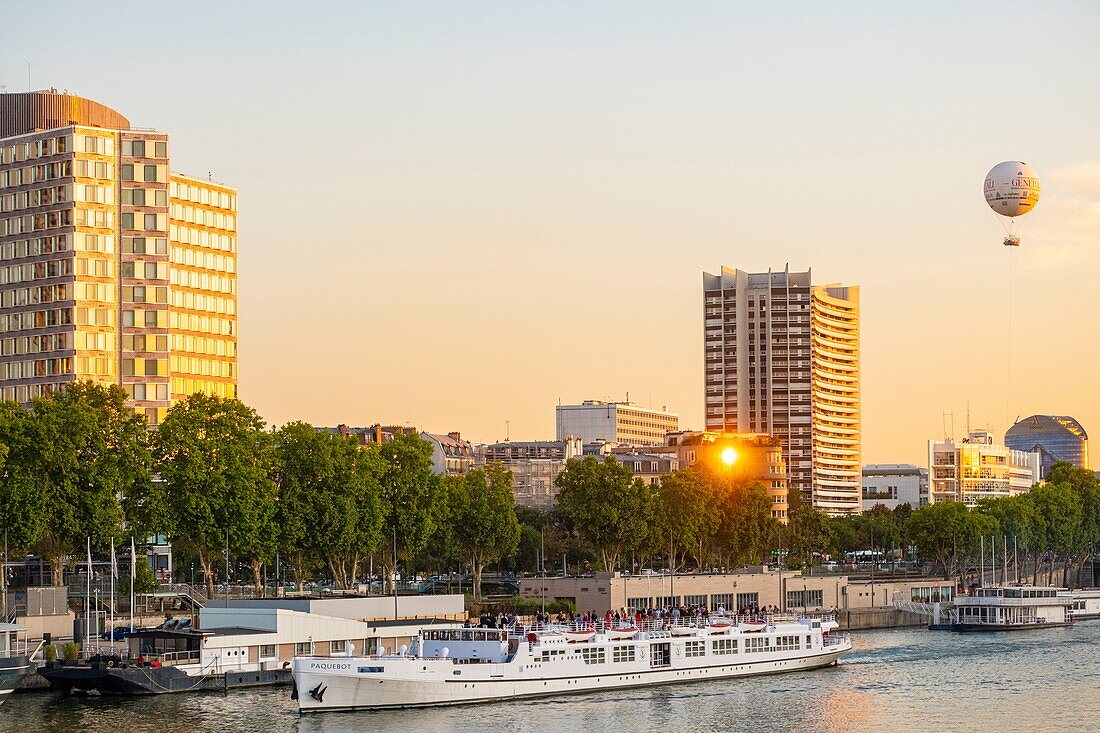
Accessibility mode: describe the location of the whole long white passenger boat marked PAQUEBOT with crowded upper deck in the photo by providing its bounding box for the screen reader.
[293,619,851,713]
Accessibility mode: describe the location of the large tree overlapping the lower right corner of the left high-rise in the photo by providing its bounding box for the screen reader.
[149,394,276,595]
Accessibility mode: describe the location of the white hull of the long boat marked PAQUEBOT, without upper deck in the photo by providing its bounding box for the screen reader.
[294,642,851,713]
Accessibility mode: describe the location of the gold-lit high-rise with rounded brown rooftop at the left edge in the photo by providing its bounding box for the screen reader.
[0,90,237,425]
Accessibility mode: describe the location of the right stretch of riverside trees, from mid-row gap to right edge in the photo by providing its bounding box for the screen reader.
[547,458,1100,582]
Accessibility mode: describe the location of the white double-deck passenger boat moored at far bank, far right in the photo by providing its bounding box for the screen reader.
[952,586,1074,632]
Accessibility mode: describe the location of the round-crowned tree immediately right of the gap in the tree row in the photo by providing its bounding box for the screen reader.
[556,456,650,572]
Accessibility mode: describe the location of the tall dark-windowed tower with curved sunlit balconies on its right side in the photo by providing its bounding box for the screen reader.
[703,267,861,514]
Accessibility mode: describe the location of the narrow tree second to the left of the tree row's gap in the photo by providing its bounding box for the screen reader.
[378,435,448,588]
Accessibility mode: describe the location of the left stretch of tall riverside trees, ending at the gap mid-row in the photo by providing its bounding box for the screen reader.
[0,382,519,594]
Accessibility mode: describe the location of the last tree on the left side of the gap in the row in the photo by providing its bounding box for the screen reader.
[448,461,519,598]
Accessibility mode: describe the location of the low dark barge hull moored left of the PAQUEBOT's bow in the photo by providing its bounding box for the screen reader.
[39,665,294,696]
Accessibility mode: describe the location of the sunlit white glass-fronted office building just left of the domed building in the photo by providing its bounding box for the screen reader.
[928,430,1040,506]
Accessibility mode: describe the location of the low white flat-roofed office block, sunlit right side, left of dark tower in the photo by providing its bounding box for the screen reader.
[557,400,680,447]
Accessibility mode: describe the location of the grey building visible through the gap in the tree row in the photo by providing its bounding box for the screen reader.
[479,437,582,511]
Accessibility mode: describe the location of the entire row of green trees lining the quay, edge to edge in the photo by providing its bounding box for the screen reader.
[0,383,1100,594]
